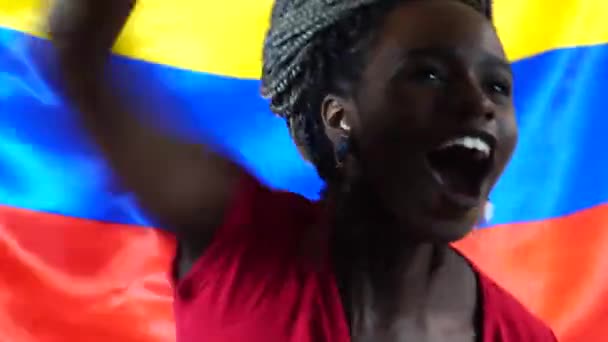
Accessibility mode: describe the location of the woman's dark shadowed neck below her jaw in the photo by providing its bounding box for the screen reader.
[326,179,448,290]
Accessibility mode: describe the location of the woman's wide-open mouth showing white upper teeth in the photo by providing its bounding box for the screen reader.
[427,134,496,201]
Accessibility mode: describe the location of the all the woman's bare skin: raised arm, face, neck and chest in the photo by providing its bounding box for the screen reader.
[50,0,517,341]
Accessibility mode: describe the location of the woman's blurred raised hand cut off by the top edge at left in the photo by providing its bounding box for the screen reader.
[49,0,136,68]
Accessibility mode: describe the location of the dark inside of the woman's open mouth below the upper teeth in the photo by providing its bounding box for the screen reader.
[429,147,484,197]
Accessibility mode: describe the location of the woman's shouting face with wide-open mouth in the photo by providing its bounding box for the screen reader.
[328,0,517,242]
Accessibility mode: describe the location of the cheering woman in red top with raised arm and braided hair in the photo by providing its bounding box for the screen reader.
[51,0,555,342]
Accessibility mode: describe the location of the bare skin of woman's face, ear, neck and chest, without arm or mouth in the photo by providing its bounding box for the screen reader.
[322,0,517,341]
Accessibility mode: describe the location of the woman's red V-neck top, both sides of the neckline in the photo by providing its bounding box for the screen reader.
[174,178,557,342]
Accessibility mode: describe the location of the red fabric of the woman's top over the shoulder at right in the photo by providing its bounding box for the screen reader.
[474,267,557,342]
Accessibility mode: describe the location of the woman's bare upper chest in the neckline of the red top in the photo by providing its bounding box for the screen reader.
[337,255,482,342]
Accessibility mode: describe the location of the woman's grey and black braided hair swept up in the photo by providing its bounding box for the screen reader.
[261,0,492,181]
